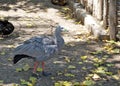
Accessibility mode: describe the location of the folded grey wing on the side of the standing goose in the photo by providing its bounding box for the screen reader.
[14,36,57,61]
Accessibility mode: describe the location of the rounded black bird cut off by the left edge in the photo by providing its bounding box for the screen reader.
[0,20,14,36]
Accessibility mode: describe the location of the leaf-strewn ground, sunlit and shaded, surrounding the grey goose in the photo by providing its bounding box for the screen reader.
[0,0,120,86]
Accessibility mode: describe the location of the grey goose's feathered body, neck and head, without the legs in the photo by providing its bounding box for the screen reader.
[13,25,64,63]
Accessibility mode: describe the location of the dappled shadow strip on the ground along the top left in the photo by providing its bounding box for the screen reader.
[0,0,60,13]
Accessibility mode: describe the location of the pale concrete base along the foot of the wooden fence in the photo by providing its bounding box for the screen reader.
[68,0,107,39]
